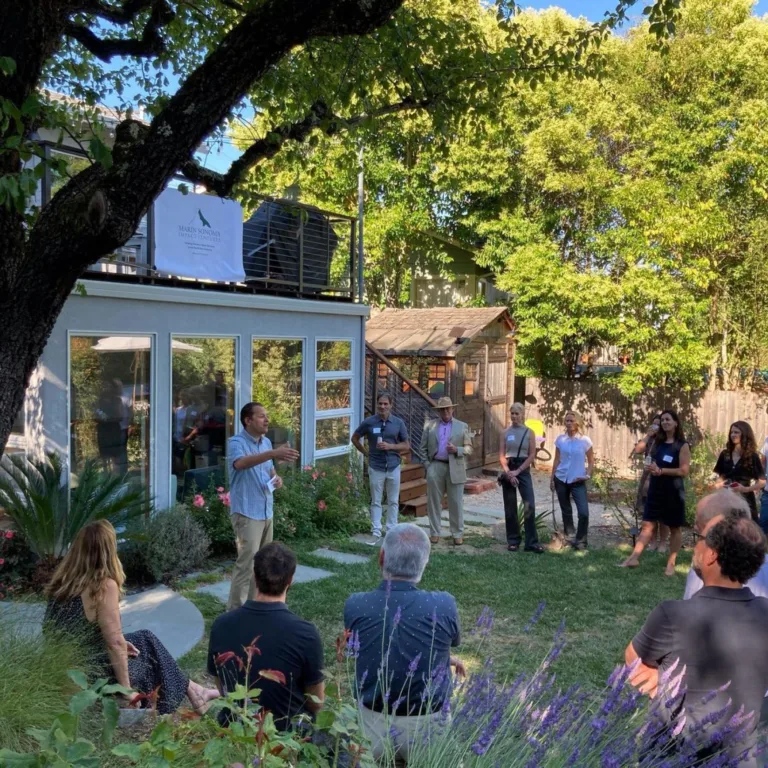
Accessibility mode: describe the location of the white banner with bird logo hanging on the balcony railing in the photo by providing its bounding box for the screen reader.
[154,188,245,283]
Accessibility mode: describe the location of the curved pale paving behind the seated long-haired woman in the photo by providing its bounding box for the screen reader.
[0,586,205,659]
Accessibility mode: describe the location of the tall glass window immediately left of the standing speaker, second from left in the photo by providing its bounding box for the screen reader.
[171,336,236,499]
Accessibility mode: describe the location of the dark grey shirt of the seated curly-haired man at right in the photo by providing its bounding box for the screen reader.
[632,587,768,766]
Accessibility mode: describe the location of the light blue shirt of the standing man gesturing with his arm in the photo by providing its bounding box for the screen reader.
[227,429,274,520]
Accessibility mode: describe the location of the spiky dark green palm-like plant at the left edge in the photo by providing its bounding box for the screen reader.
[0,453,151,562]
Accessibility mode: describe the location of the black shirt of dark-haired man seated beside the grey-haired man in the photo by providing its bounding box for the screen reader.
[208,600,323,730]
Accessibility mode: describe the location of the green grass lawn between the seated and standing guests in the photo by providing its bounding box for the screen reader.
[177,537,690,686]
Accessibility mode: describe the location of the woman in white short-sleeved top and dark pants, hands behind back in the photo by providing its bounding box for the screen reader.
[549,411,595,549]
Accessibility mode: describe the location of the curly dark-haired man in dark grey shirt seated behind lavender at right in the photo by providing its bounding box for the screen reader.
[625,513,768,768]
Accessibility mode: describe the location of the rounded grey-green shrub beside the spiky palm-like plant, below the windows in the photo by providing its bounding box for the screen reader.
[120,505,210,582]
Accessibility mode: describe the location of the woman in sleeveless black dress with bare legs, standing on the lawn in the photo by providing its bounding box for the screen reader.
[621,411,691,576]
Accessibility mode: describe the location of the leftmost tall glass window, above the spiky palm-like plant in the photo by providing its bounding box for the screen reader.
[69,336,152,485]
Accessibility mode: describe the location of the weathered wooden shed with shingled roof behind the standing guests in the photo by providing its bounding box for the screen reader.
[365,307,515,470]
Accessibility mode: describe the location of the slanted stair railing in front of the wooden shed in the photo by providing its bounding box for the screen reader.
[365,341,437,462]
